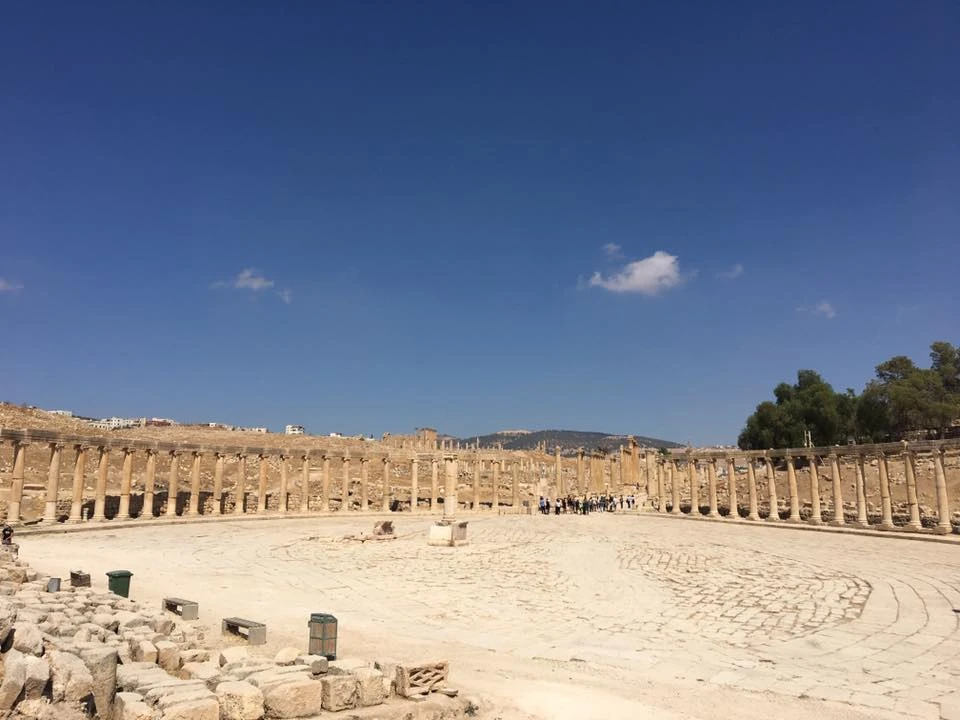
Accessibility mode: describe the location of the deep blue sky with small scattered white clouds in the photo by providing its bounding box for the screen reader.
[0,2,960,444]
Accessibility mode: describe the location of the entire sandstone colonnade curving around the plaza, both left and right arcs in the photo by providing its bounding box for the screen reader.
[0,428,960,533]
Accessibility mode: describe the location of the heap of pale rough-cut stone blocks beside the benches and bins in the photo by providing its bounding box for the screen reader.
[0,545,462,720]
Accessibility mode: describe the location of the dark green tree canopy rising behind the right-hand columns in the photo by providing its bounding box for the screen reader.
[738,340,960,450]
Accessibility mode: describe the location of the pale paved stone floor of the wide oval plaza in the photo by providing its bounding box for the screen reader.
[21,514,960,718]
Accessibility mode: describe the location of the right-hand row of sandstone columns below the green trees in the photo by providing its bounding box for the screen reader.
[647,445,951,533]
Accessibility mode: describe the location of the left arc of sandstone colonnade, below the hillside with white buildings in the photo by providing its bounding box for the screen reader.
[0,428,540,523]
